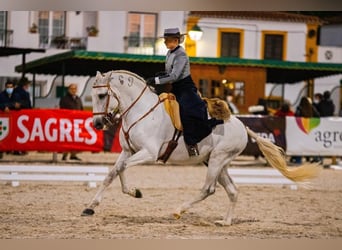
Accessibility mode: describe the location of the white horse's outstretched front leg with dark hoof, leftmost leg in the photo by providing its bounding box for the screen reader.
[81,152,127,216]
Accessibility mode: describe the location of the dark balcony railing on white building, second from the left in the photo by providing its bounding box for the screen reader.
[39,36,88,49]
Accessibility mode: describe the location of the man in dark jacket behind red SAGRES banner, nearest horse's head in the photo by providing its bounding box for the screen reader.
[59,83,83,161]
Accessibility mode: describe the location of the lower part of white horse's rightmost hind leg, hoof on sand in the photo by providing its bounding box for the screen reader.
[215,167,238,226]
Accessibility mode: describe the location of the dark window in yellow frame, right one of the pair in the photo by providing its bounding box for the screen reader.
[262,33,286,60]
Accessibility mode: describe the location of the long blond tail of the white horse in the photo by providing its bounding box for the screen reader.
[246,127,322,182]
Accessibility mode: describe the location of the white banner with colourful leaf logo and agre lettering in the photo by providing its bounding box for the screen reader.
[285,117,342,156]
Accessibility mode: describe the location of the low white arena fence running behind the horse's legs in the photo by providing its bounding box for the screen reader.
[0,165,297,189]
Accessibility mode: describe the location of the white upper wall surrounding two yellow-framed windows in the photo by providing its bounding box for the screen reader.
[197,18,307,61]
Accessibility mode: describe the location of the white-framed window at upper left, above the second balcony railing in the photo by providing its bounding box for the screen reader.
[38,11,65,47]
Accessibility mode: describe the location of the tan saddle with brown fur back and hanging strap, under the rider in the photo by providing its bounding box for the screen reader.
[157,93,231,163]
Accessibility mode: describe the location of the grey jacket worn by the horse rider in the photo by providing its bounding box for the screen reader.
[155,46,190,84]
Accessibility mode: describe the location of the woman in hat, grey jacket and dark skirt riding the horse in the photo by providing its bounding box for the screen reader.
[146,28,223,157]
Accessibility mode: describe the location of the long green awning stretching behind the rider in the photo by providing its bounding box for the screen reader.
[15,50,342,83]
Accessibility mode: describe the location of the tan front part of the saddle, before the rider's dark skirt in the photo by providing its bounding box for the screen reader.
[159,93,183,131]
